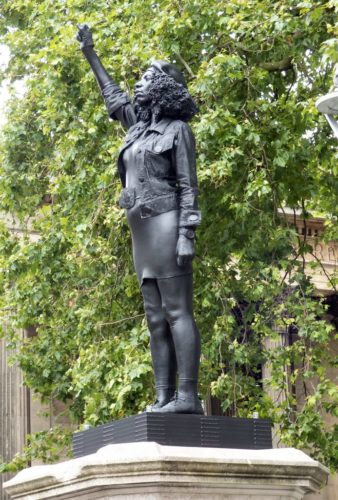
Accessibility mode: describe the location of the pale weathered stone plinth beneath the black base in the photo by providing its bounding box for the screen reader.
[5,442,328,500]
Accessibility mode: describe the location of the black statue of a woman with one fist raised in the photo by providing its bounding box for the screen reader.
[77,25,203,414]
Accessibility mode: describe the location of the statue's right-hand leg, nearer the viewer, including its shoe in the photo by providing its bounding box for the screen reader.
[157,274,202,413]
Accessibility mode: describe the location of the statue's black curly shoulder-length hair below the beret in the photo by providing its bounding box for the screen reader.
[135,73,198,122]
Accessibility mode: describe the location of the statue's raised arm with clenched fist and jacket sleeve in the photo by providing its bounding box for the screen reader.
[76,24,137,128]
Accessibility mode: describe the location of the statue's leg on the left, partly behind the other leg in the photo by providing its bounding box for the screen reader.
[141,279,177,406]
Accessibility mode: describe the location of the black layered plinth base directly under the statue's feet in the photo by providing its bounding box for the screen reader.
[73,413,272,457]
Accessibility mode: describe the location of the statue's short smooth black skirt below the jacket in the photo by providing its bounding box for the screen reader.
[126,198,192,286]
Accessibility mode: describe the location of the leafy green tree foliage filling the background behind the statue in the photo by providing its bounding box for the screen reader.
[0,0,338,467]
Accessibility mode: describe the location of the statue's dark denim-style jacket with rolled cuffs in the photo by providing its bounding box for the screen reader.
[102,81,201,228]
